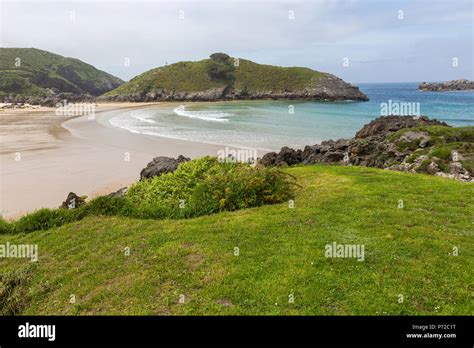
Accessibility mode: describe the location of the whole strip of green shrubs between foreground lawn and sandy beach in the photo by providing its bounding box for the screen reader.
[4,157,295,233]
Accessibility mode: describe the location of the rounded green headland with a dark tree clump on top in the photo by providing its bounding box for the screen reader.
[105,53,368,101]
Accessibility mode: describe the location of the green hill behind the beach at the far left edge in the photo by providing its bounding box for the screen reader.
[0,48,123,97]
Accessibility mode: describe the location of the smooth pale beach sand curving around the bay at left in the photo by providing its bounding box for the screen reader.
[0,103,222,219]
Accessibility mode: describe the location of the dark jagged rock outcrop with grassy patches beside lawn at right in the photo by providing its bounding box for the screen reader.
[259,116,474,181]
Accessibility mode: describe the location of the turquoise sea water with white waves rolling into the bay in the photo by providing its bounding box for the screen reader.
[110,83,474,150]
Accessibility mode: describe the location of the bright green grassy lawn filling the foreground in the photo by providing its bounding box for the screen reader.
[0,165,474,315]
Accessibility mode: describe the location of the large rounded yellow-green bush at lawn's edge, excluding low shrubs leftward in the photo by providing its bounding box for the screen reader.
[126,157,295,218]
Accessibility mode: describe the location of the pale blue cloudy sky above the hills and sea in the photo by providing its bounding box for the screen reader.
[0,0,474,83]
